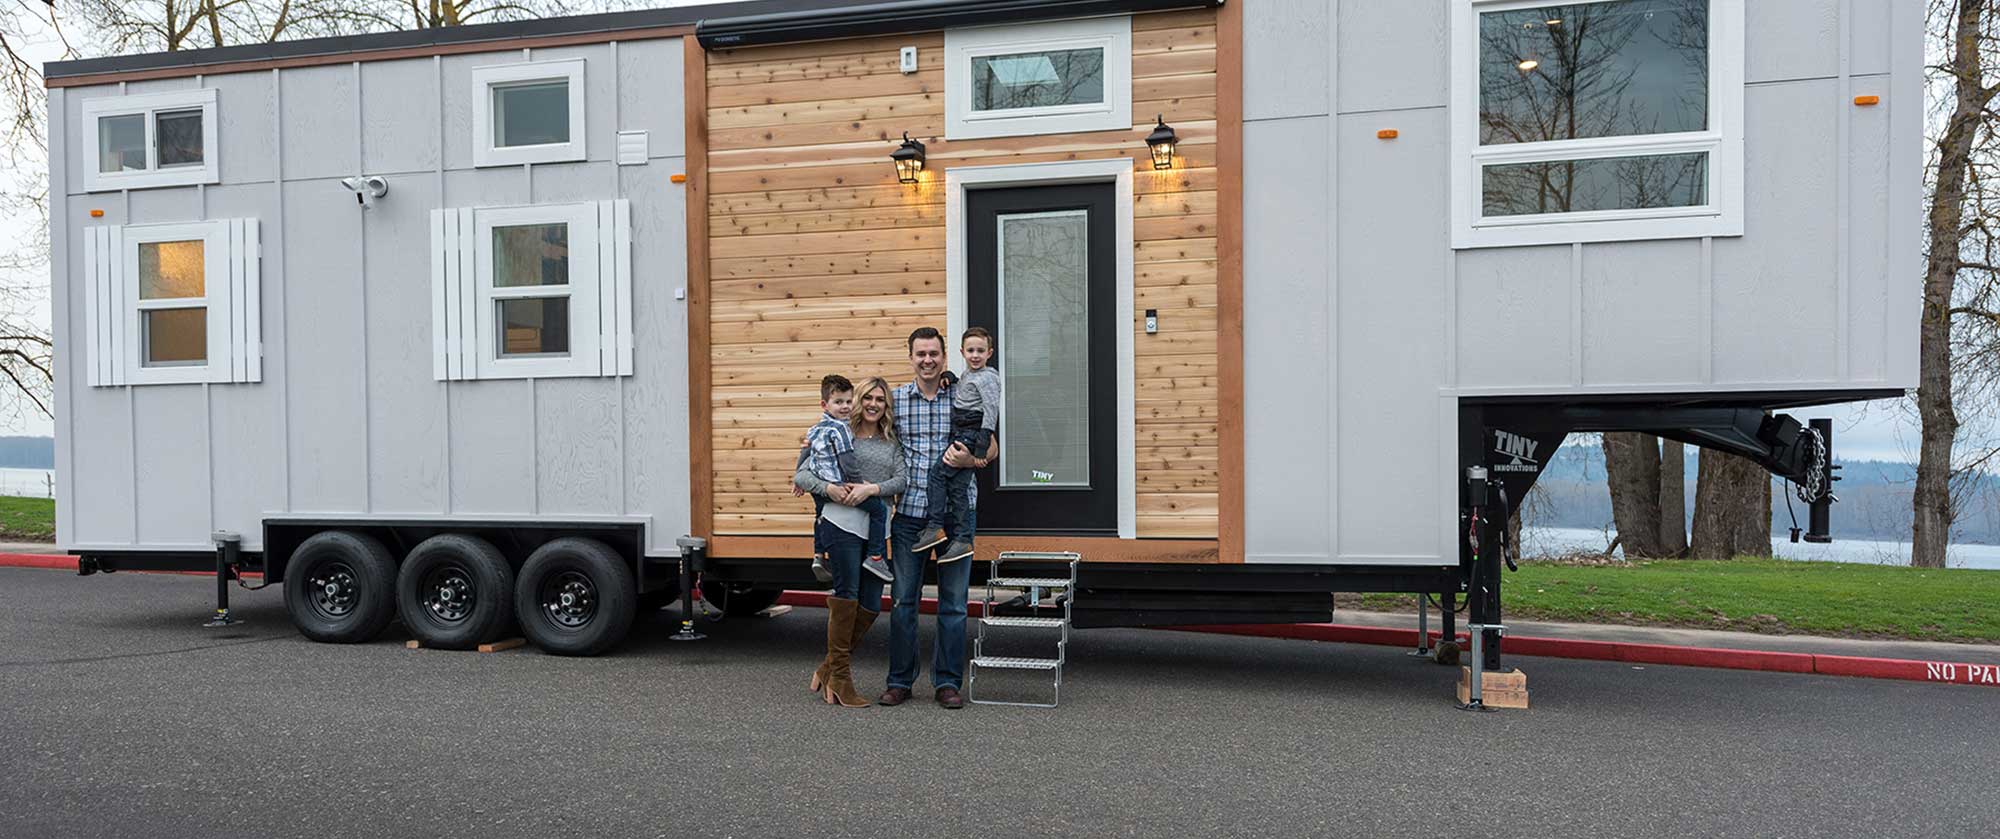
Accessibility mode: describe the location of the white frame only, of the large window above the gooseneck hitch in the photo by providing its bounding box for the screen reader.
[1452,0,1744,250]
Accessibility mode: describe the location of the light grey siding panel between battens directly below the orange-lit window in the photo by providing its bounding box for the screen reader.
[132,384,208,545]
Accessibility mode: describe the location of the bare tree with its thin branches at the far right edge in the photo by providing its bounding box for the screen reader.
[1910,0,2000,567]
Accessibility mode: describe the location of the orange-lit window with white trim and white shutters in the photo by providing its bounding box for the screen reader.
[84,218,264,388]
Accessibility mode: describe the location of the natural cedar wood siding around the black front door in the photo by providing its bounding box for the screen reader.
[696,10,1234,561]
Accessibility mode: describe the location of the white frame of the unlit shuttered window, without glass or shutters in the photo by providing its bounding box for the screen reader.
[472,204,598,380]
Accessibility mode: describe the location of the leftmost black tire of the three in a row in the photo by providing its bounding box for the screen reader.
[284,529,396,643]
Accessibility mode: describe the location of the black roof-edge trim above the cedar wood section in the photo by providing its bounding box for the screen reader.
[694,0,1222,50]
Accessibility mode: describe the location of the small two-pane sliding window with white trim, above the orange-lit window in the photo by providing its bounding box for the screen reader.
[82,88,222,192]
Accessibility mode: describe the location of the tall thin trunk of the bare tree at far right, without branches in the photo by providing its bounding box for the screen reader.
[1910,0,1994,567]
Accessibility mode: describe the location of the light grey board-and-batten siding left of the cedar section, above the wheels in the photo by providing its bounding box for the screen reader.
[50,38,688,553]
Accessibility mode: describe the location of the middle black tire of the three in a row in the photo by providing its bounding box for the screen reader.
[396,533,514,649]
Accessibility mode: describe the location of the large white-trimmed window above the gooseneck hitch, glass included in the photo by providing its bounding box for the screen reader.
[1452,0,1744,248]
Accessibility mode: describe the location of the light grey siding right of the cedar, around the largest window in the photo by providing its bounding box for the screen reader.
[1244,0,1924,565]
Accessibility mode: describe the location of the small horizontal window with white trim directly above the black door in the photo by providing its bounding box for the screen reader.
[944,18,1132,140]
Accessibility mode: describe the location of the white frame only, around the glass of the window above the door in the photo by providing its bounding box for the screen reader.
[944,16,1132,140]
